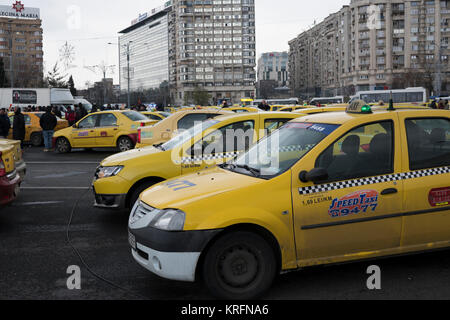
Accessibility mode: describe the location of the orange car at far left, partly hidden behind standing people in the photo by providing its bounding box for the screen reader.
[8,112,69,147]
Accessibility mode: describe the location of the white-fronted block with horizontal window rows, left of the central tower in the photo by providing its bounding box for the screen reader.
[119,2,172,91]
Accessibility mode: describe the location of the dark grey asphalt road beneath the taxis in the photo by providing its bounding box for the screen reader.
[0,148,450,300]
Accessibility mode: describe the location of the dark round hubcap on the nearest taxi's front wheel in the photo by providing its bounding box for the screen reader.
[219,246,259,288]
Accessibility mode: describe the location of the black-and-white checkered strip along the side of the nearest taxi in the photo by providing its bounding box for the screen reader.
[299,167,450,195]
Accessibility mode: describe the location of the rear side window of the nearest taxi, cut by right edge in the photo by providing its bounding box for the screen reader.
[405,118,450,170]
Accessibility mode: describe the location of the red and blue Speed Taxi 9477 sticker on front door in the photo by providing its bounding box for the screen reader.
[328,190,379,218]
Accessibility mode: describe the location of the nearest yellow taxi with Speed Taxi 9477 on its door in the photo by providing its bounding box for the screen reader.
[129,103,450,299]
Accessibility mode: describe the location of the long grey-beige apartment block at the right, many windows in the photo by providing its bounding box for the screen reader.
[289,0,450,97]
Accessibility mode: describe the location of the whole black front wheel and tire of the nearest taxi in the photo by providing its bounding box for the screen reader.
[202,231,277,300]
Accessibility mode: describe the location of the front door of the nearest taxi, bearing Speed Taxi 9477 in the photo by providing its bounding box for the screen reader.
[292,115,403,265]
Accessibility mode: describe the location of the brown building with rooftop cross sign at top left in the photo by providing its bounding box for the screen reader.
[0,1,44,88]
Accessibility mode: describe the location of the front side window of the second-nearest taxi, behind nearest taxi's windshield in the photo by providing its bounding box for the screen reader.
[190,121,255,154]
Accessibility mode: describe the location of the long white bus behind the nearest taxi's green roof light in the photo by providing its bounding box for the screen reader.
[350,88,427,104]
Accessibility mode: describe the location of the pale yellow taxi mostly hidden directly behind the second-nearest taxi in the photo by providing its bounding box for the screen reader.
[136,109,231,149]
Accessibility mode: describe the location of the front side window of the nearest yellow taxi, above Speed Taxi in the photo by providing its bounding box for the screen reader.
[316,121,394,182]
